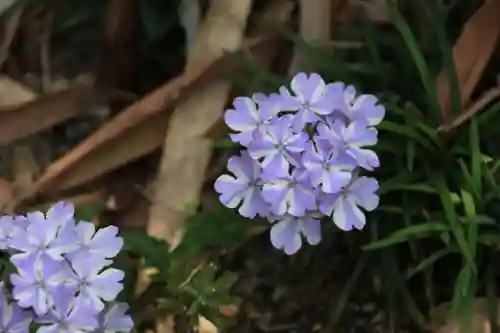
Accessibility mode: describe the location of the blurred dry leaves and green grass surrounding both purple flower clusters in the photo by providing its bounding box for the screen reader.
[0,0,500,333]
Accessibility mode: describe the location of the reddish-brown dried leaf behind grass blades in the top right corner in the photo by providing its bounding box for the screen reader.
[436,0,500,121]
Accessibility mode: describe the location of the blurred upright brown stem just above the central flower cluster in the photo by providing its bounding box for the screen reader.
[289,0,332,75]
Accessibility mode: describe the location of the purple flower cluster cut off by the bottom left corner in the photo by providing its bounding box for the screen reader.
[0,202,133,333]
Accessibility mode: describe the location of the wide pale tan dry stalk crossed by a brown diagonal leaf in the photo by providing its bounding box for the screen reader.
[147,0,251,247]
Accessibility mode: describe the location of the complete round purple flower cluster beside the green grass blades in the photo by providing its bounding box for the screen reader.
[215,73,385,254]
